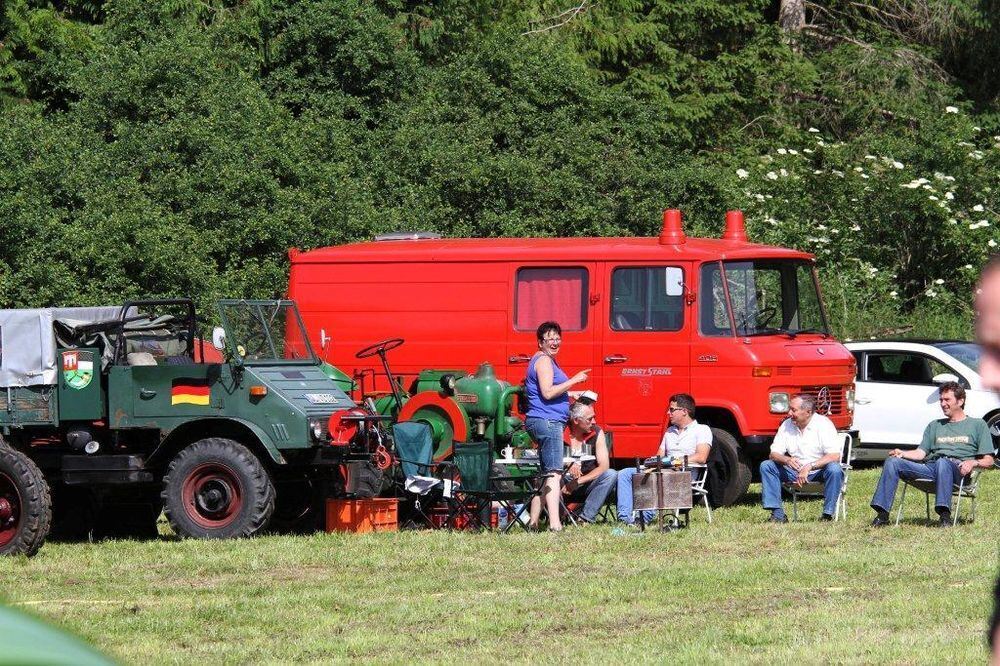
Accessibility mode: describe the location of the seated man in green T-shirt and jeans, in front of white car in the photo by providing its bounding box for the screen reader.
[872,382,993,527]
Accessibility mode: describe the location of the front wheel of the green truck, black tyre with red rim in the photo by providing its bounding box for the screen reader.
[162,437,274,539]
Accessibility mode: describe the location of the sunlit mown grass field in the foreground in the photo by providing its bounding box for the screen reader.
[0,469,1000,663]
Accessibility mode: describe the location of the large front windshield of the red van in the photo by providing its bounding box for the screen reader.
[700,259,829,337]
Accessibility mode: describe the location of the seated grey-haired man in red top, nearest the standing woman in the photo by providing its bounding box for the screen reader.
[562,400,618,523]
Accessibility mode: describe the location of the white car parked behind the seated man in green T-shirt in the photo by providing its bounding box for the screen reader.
[845,340,1000,460]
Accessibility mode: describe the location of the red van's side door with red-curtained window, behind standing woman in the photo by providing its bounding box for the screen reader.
[505,263,597,391]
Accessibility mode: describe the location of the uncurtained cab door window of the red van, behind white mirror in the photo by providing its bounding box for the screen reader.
[610,266,684,331]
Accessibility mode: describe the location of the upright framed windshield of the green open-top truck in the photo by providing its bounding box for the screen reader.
[220,301,315,363]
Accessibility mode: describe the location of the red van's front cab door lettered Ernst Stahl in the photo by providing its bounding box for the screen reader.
[595,263,691,458]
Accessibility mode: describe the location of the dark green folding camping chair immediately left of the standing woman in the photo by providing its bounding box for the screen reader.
[446,442,541,532]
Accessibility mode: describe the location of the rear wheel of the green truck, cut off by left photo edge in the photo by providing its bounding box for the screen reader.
[0,439,52,557]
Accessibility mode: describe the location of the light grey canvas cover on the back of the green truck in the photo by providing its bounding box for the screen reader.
[0,306,129,387]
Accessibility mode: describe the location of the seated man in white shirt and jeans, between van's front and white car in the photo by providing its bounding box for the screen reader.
[760,395,844,523]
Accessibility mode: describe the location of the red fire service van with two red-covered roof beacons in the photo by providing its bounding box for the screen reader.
[288,210,855,503]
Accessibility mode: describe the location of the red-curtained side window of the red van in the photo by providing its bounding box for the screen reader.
[514,266,589,331]
